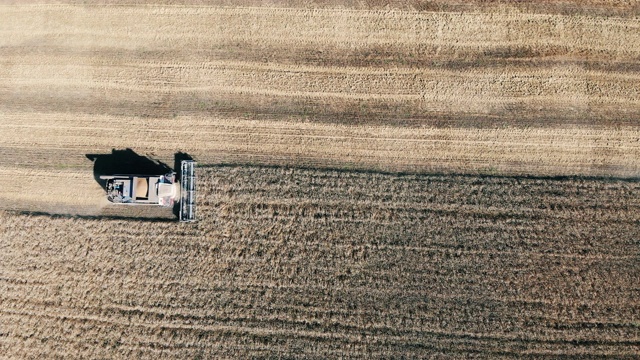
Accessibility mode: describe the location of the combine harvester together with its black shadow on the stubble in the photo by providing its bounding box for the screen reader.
[86,148,196,221]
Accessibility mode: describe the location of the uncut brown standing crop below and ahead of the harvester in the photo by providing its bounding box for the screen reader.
[0,166,640,358]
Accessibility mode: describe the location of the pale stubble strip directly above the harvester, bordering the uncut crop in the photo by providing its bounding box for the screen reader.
[0,112,640,178]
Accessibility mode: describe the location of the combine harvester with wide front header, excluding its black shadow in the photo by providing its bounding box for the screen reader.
[100,160,196,222]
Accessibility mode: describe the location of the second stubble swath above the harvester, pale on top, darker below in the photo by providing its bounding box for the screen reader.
[3,46,640,127]
